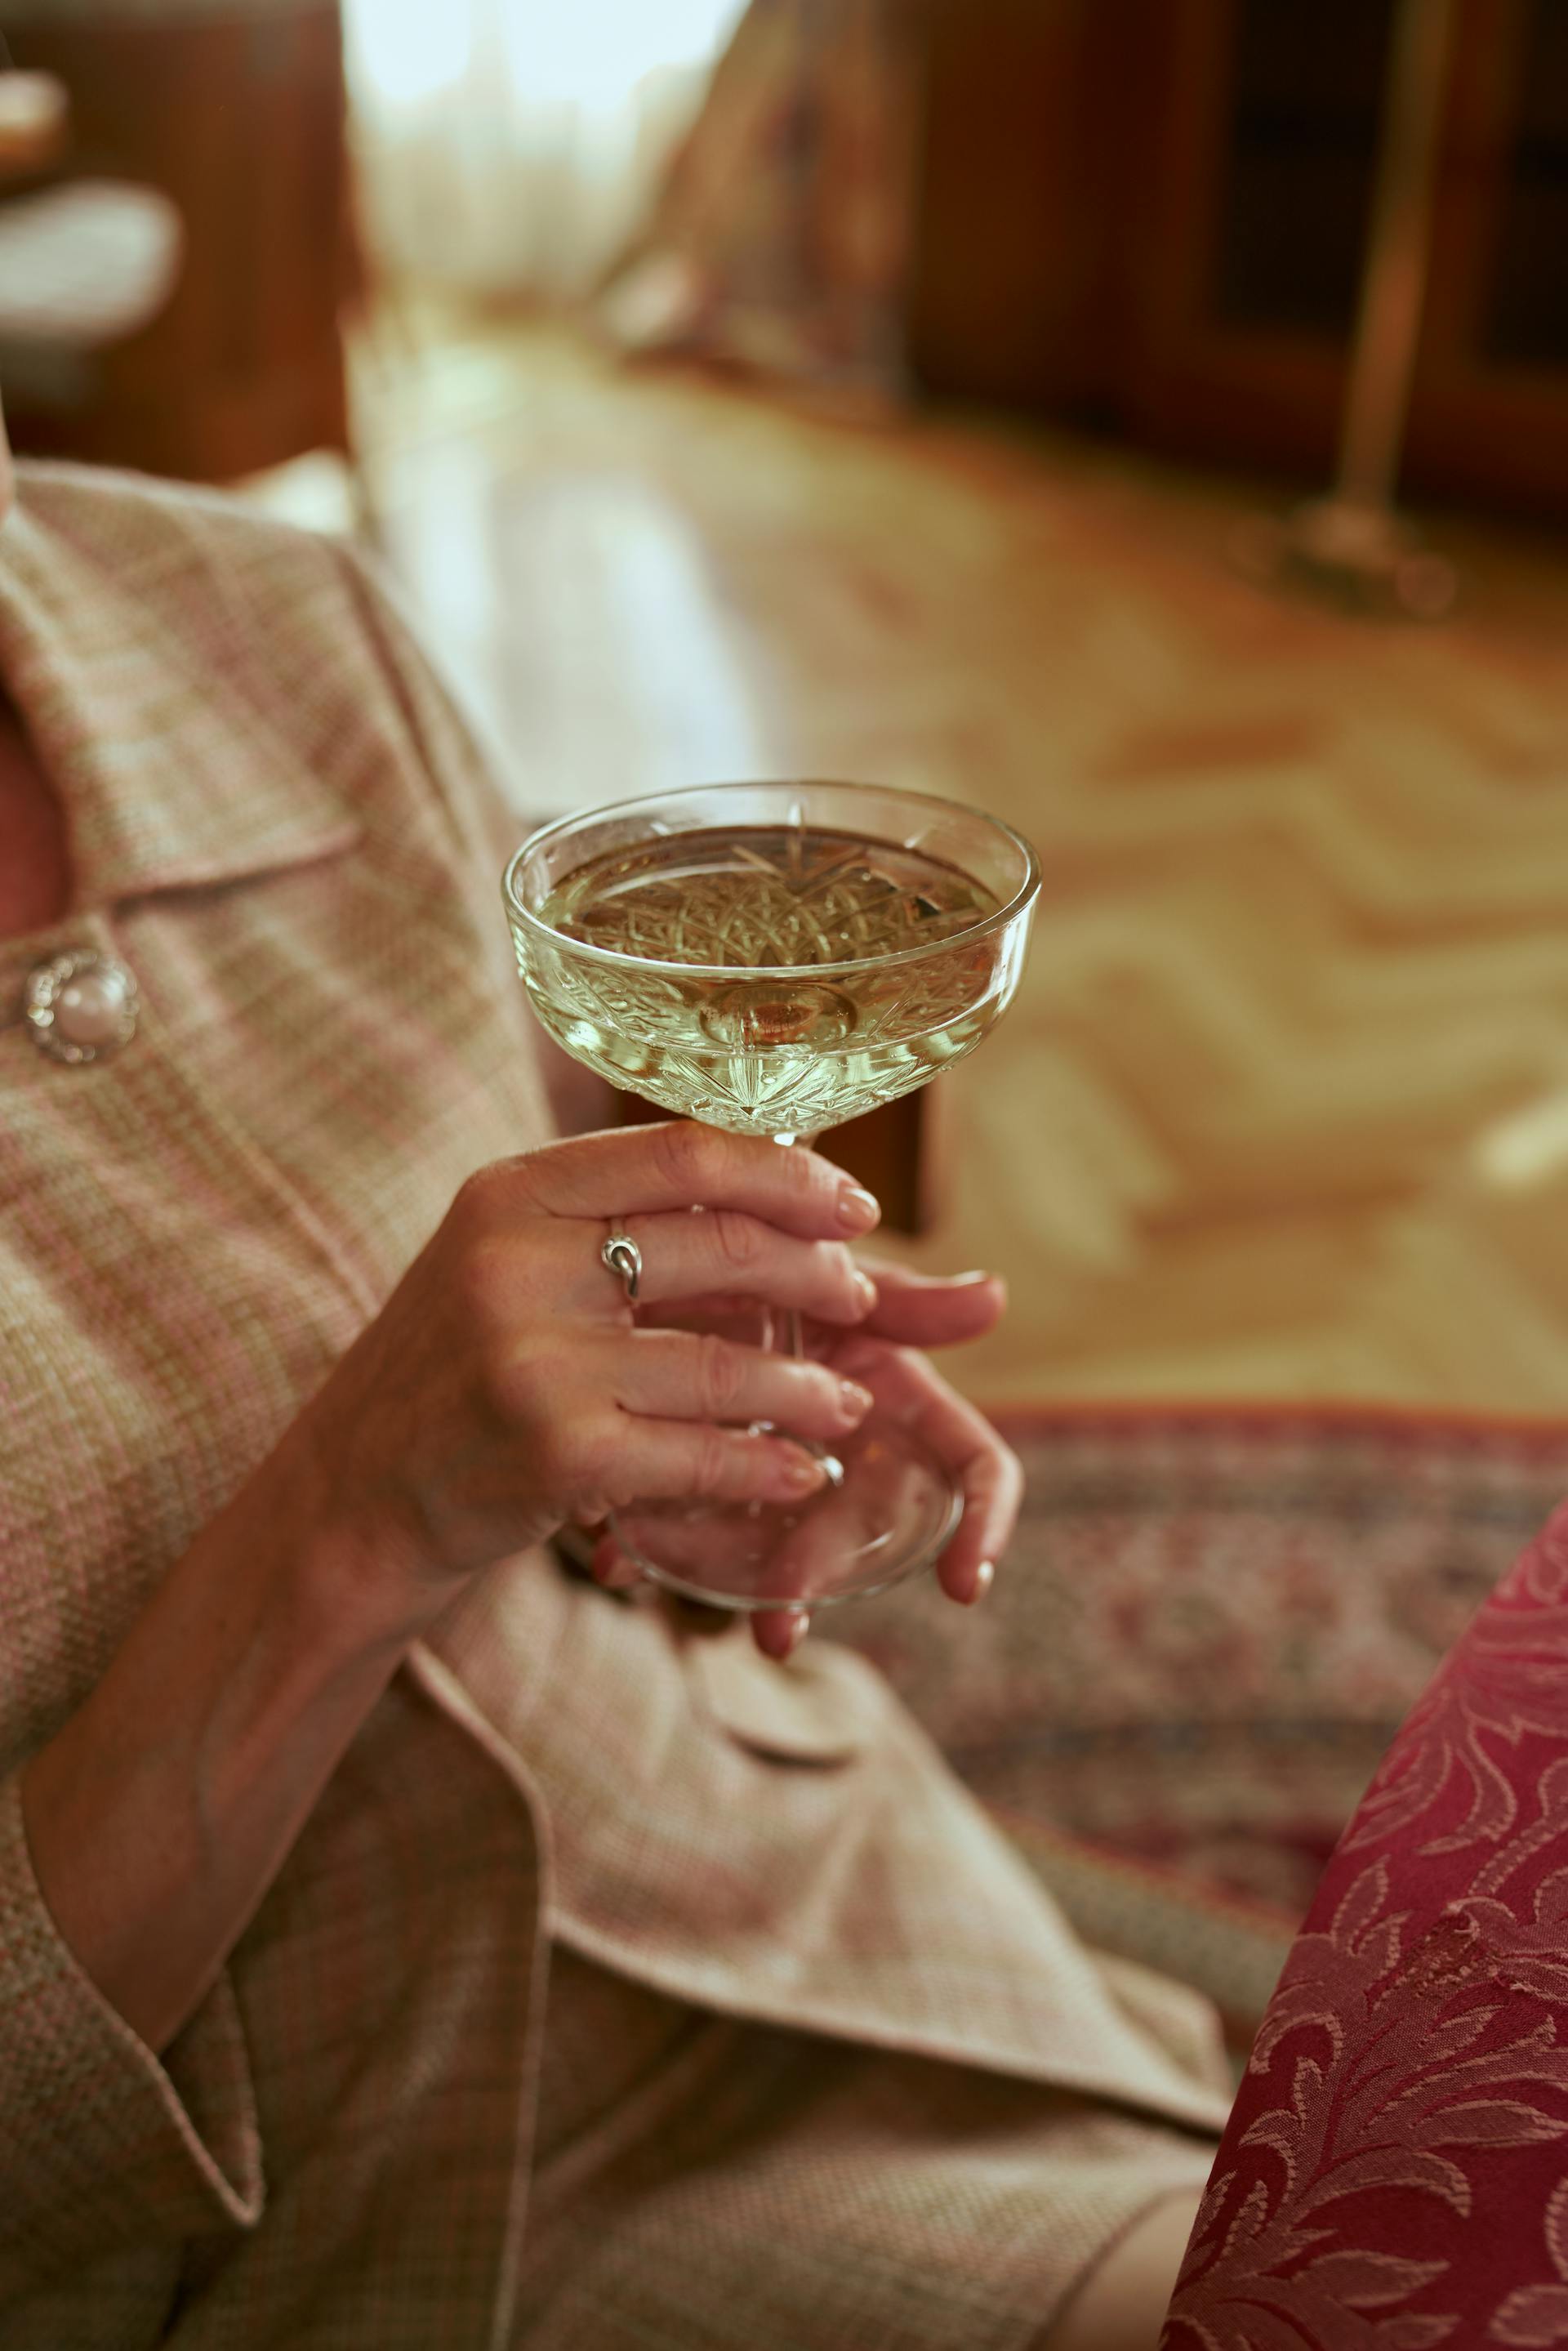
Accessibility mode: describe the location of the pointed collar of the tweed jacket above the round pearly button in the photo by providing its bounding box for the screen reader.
[0,468,359,912]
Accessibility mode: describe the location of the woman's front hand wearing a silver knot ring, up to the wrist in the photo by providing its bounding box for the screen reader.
[289,1124,877,1625]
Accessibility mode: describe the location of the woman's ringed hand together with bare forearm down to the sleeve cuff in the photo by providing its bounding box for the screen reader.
[21,1126,877,2050]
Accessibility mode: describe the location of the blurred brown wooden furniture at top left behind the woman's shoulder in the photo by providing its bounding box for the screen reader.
[7,0,353,482]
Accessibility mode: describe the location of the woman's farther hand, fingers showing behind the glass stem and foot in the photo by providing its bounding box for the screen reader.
[592,1265,1022,1657]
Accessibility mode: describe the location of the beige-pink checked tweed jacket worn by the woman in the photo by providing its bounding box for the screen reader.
[0,468,1223,2351]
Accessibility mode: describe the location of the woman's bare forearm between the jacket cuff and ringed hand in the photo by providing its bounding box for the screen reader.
[21,1443,433,2050]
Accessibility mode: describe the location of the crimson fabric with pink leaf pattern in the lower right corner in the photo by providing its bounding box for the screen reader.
[1161,1510,1568,2351]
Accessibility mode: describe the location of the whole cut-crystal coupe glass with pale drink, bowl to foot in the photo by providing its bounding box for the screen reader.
[503,783,1039,1608]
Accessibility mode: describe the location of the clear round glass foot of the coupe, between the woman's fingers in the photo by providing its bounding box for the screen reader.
[611,1411,964,1610]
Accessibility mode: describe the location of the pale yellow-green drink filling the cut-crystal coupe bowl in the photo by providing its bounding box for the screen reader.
[517,825,1018,1135]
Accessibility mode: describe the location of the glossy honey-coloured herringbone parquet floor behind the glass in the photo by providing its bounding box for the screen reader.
[341,312,1568,1416]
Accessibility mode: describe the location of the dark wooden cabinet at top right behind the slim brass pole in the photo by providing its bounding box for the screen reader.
[910,0,1568,515]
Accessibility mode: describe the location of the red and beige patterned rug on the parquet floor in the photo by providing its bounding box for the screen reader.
[825,1406,1568,2029]
